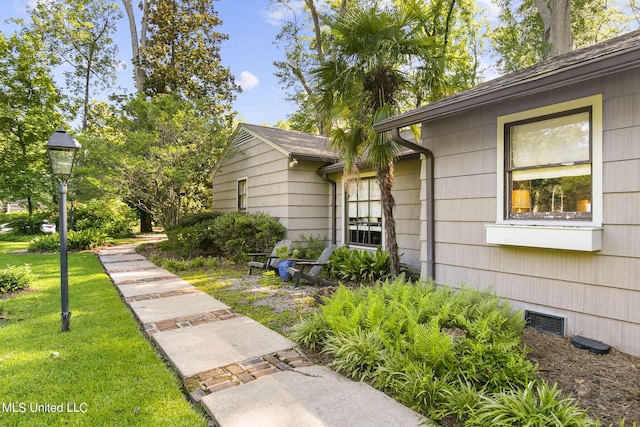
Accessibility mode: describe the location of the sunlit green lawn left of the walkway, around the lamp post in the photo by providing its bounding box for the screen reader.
[0,242,206,426]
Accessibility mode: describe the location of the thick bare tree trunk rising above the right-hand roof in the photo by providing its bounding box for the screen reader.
[535,0,573,58]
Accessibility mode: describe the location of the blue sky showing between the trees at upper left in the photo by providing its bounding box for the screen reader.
[0,0,295,125]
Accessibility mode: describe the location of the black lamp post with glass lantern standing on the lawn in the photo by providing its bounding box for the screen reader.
[47,128,81,332]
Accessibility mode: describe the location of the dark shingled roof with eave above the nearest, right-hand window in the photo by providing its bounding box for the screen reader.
[375,30,640,132]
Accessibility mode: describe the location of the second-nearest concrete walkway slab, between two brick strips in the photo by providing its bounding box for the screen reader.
[151,314,295,378]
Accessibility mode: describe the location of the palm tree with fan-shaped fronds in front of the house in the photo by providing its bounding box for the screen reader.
[315,1,435,276]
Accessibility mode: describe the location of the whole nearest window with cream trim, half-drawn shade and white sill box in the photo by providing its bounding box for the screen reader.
[485,95,603,251]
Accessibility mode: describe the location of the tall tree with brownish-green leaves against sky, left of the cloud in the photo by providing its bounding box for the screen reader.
[123,0,240,116]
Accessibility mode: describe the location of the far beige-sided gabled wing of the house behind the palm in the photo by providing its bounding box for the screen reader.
[213,124,421,270]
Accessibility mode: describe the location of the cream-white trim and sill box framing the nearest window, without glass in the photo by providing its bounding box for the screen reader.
[485,94,603,252]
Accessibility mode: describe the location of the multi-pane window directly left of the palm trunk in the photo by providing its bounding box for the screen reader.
[347,177,382,246]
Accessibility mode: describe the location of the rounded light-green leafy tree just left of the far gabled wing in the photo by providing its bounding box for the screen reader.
[83,94,234,226]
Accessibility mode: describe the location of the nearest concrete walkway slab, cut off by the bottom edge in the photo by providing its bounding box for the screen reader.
[201,365,426,427]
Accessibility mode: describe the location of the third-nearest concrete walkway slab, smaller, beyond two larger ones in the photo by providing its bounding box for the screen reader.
[129,294,230,329]
